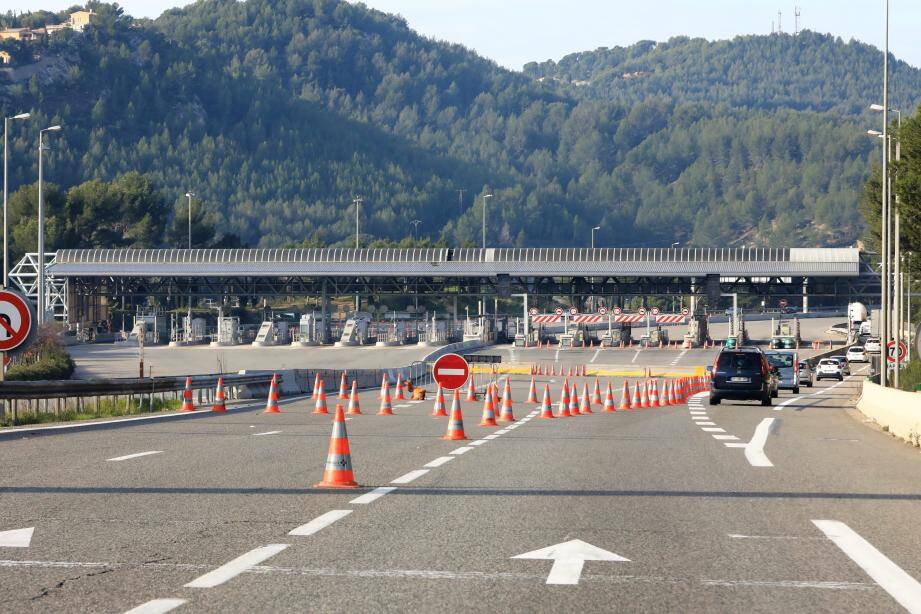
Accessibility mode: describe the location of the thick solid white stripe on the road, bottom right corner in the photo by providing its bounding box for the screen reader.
[812,520,921,614]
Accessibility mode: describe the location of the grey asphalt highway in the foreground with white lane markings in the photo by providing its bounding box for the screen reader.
[0,364,921,612]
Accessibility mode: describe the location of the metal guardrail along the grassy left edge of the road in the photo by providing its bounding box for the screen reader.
[0,373,272,400]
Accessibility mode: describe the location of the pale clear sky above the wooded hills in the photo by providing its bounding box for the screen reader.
[12,0,921,70]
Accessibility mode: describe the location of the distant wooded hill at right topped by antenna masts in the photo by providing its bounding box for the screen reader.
[524,30,921,114]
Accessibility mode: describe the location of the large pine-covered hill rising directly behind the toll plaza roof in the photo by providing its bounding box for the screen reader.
[0,0,900,247]
